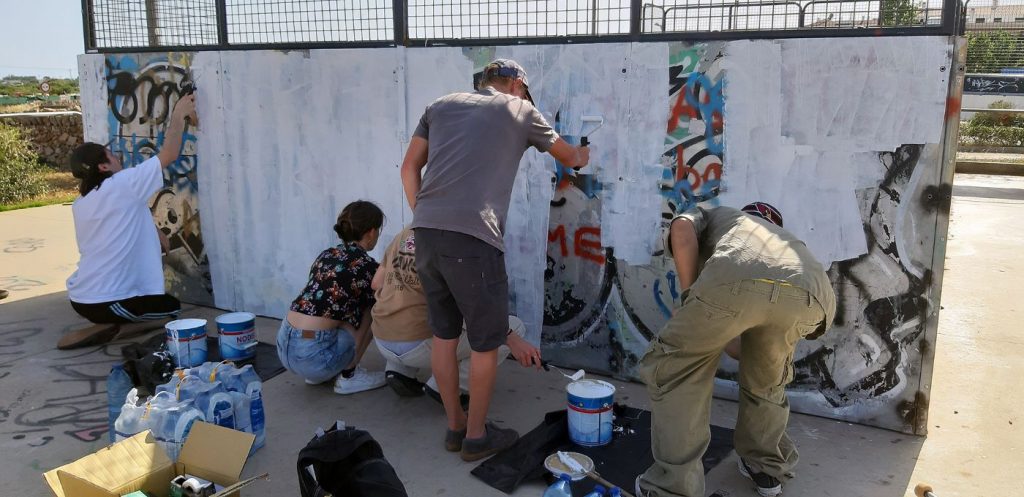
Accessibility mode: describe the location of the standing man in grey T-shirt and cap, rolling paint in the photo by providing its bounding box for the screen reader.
[401,58,590,461]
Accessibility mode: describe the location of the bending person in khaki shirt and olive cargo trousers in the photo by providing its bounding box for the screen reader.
[636,202,836,497]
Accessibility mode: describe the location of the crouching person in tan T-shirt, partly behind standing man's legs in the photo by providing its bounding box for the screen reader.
[371,226,541,405]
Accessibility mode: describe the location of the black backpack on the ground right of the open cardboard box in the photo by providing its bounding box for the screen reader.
[298,421,409,497]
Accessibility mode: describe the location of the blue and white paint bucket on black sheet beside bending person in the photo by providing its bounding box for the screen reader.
[565,379,615,447]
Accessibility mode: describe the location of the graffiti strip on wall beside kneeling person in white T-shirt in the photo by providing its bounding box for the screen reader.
[105,54,213,304]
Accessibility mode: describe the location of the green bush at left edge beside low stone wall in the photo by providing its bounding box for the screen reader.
[0,122,49,204]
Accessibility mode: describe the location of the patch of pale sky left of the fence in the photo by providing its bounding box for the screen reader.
[0,0,85,78]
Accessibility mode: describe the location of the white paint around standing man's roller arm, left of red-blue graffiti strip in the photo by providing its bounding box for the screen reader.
[495,43,669,341]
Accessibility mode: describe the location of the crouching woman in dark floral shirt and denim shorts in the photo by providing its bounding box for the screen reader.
[278,200,384,395]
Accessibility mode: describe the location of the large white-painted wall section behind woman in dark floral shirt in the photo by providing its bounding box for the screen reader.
[193,49,406,317]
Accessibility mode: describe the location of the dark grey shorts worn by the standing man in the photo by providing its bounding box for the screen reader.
[415,227,509,353]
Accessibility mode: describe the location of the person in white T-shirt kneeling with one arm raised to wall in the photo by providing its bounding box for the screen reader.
[57,94,198,349]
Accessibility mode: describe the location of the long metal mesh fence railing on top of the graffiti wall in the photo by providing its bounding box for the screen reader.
[81,0,966,51]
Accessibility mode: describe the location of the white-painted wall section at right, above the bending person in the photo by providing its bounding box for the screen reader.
[721,37,949,266]
